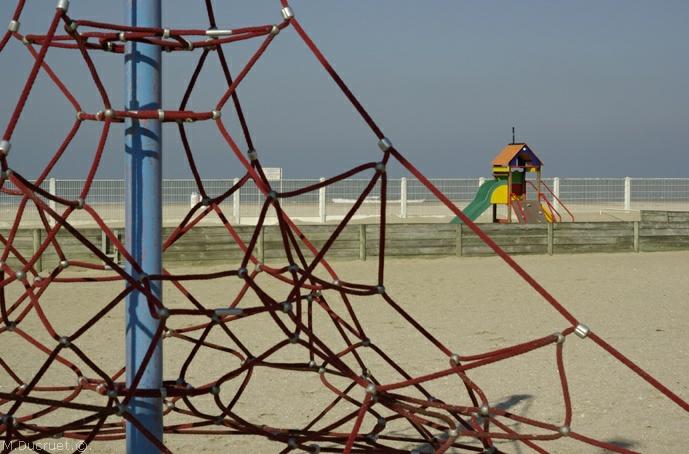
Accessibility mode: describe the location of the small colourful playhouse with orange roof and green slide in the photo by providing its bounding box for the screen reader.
[452,138,574,224]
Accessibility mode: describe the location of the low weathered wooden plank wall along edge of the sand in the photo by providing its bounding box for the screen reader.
[5,211,689,269]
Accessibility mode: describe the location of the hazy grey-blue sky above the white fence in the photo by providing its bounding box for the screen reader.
[0,0,689,178]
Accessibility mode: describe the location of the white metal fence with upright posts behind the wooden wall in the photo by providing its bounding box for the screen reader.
[0,178,689,226]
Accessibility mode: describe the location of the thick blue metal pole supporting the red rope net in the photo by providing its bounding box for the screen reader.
[124,0,163,454]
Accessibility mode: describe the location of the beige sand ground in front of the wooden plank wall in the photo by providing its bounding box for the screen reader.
[0,252,689,453]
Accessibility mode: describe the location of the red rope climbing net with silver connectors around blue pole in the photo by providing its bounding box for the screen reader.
[0,0,689,452]
